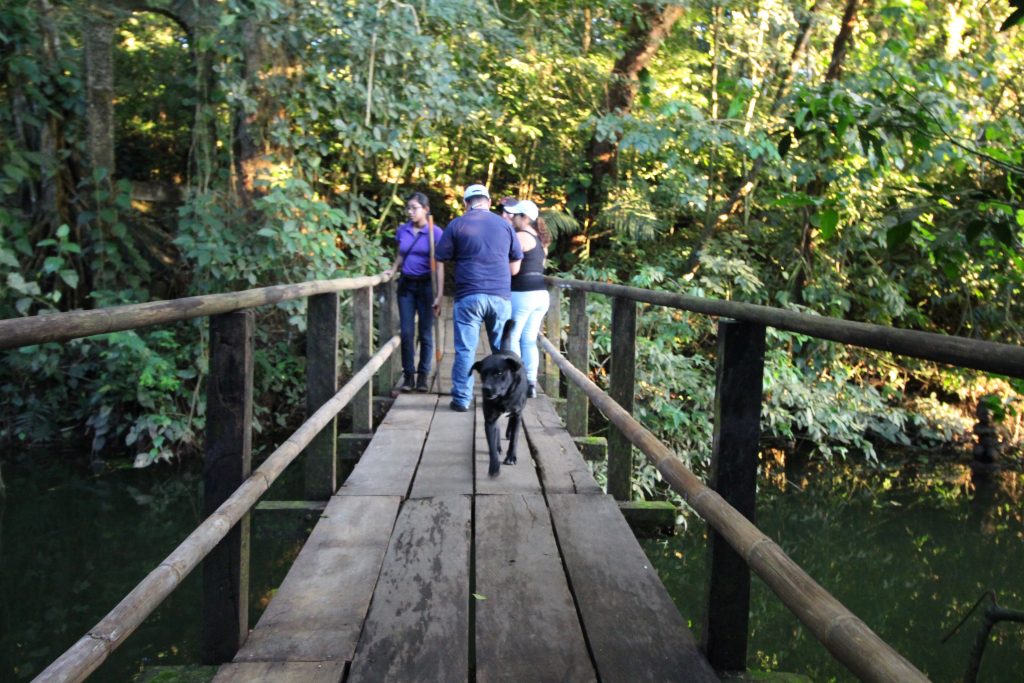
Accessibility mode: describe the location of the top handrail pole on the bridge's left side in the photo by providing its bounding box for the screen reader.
[0,274,389,349]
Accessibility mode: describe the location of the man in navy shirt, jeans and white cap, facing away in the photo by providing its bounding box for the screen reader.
[435,185,522,413]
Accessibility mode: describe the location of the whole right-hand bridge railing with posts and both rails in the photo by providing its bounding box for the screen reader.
[541,278,1024,681]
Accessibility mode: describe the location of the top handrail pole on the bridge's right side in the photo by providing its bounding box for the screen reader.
[545,276,1024,379]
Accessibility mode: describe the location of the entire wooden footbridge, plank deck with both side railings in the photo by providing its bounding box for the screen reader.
[14,275,974,683]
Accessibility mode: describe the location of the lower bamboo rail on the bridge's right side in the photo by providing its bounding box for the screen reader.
[538,335,928,683]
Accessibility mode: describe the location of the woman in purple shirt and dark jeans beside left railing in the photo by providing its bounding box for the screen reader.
[385,193,444,391]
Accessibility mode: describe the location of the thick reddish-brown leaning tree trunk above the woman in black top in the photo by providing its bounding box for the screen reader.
[587,2,683,225]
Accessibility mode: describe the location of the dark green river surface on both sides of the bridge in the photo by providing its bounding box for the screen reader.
[0,456,1024,683]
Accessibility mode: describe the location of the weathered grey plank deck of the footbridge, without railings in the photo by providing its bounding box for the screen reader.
[215,321,718,683]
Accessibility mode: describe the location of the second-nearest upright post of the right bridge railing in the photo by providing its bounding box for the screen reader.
[608,297,637,501]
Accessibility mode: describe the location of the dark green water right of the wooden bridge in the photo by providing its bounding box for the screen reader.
[643,465,1024,683]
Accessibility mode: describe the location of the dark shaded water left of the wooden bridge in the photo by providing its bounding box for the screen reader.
[0,458,302,683]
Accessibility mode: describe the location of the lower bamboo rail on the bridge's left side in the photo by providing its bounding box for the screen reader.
[34,335,401,683]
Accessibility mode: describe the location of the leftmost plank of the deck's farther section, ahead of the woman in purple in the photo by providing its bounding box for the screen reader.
[338,393,437,498]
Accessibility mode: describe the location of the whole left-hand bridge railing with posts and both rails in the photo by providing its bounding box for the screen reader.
[0,275,399,682]
